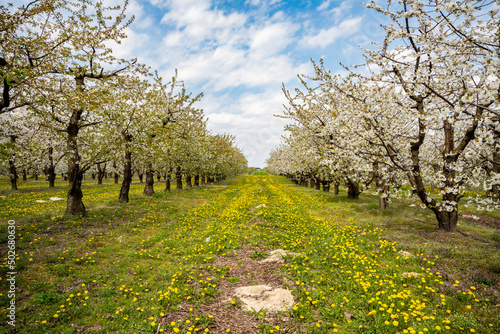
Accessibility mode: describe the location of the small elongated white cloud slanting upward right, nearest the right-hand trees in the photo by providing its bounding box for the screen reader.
[300,17,362,48]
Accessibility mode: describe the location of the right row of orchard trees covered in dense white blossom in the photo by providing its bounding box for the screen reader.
[268,0,500,231]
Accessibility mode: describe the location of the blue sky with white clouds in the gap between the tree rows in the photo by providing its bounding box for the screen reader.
[114,0,382,167]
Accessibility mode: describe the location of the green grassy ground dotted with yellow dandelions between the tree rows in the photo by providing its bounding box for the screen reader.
[0,175,500,333]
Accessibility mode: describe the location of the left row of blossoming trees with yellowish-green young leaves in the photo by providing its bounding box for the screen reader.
[0,0,247,215]
